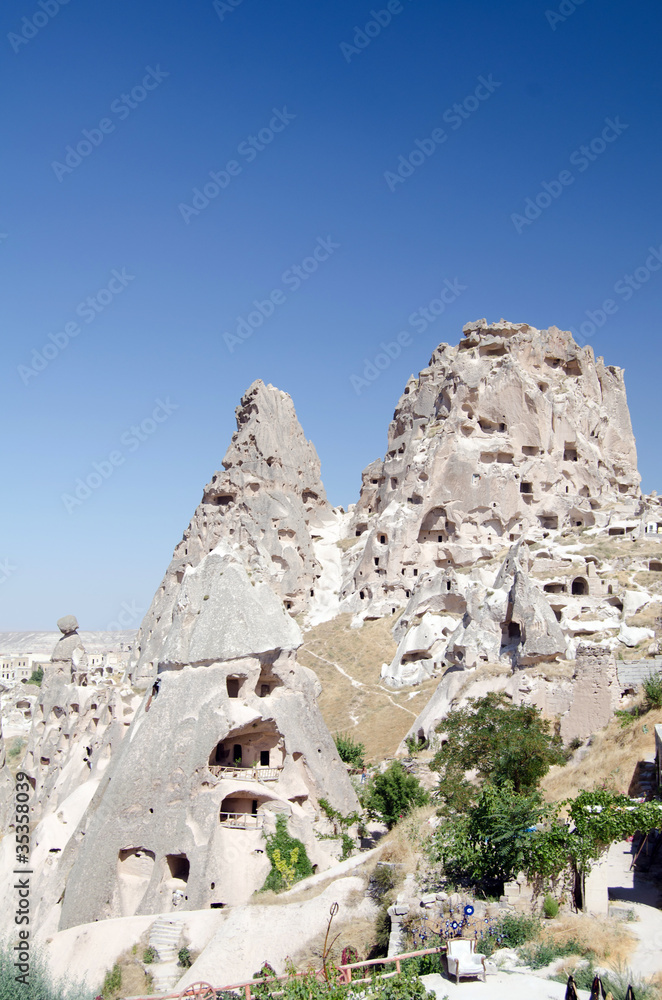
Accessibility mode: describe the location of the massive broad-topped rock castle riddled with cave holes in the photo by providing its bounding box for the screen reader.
[341,320,640,618]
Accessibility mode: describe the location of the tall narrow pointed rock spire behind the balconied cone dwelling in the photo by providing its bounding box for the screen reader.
[131,379,332,687]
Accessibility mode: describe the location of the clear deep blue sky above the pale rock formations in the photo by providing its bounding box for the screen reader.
[0,0,662,629]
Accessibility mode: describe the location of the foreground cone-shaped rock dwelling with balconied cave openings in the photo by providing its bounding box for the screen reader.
[54,542,358,929]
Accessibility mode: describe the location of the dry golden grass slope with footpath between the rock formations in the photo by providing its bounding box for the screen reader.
[298,615,438,761]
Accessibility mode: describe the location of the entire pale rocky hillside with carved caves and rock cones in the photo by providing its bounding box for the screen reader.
[0,320,662,972]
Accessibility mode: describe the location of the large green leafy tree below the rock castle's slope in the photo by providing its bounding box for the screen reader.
[430,692,565,804]
